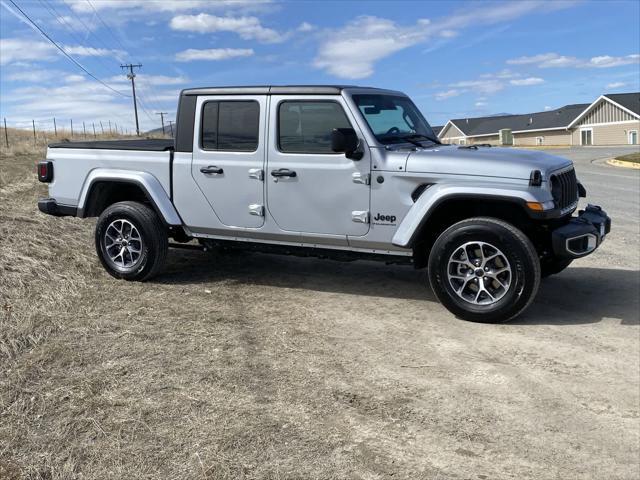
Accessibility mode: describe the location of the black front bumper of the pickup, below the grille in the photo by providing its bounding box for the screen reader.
[551,205,611,258]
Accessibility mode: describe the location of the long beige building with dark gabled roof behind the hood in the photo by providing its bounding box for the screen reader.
[438,93,640,146]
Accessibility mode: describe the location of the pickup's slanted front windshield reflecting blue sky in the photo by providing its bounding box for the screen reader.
[353,95,440,145]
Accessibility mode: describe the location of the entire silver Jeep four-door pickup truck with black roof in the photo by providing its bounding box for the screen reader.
[38,86,611,322]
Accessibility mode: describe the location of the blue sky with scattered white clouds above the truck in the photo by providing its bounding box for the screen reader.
[0,0,640,130]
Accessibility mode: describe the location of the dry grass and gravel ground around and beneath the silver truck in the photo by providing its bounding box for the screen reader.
[0,148,640,480]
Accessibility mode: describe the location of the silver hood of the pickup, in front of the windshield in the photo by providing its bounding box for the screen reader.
[406,145,572,180]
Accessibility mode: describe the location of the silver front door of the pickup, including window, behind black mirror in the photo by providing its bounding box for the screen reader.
[265,95,371,237]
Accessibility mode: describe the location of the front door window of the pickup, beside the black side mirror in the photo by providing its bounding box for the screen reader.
[278,100,351,153]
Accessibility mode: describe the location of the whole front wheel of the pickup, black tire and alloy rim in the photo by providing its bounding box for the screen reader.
[429,217,540,322]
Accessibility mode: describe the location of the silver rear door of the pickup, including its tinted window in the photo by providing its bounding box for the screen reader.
[191,95,267,228]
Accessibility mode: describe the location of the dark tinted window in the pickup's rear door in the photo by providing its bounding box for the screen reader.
[201,100,260,152]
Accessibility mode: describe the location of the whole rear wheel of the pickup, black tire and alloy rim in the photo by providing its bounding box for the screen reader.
[95,202,169,281]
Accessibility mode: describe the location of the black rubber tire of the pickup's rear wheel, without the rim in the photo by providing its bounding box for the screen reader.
[95,202,169,281]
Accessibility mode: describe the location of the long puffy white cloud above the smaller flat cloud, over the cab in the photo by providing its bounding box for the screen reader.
[169,13,286,43]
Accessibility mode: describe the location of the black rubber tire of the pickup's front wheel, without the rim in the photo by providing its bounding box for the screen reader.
[428,217,541,323]
